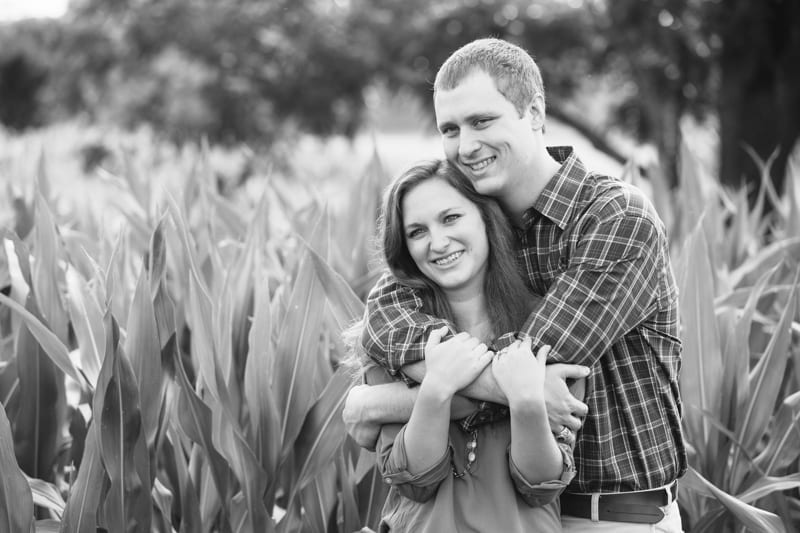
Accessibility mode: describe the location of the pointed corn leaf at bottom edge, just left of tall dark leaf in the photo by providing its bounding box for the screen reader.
[61,420,106,533]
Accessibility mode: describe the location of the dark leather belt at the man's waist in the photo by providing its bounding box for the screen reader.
[561,481,678,524]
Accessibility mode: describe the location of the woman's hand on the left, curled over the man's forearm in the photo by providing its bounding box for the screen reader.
[423,327,494,397]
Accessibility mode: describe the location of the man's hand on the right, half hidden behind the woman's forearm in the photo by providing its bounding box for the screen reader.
[544,363,589,433]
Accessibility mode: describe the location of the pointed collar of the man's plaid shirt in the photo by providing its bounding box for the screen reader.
[522,146,587,231]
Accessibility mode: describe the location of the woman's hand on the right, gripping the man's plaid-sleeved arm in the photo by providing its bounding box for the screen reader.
[492,337,550,407]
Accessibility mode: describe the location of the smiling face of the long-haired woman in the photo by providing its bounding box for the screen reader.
[401,178,489,292]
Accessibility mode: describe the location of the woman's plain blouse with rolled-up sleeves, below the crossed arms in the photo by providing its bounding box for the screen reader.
[376,419,575,533]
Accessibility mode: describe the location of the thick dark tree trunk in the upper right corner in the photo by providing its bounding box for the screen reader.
[718,0,800,194]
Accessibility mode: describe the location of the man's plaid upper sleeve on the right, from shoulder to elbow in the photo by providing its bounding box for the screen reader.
[523,203,664,366]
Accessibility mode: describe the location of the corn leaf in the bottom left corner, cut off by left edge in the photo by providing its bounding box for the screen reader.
[0,405,33,532]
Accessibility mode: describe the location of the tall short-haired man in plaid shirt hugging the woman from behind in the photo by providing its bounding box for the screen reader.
[345,39,686,531]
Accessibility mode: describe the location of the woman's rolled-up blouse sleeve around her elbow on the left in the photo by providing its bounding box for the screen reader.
[375,424,453,502]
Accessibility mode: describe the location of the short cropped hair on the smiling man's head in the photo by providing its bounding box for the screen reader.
[433,38,544,116]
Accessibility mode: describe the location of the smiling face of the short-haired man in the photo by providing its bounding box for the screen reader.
[433,70,536,197]
